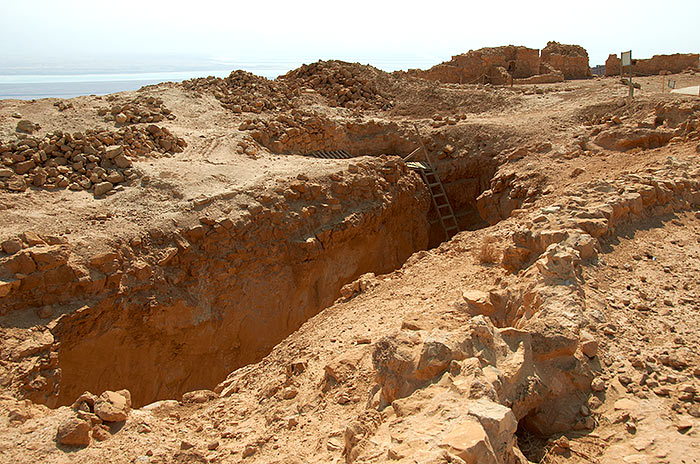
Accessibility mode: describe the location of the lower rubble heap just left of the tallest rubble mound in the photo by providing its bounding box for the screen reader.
[182,70,294,113]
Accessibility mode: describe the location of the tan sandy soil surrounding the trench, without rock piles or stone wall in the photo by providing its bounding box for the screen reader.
[0,60,700,463]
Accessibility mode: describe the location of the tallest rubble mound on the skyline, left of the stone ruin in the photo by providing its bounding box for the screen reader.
[281,60,392,110]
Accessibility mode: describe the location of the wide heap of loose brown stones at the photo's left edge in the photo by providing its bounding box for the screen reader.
[0,125,187,196]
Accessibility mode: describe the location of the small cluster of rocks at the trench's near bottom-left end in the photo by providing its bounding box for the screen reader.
[56,390,131,447]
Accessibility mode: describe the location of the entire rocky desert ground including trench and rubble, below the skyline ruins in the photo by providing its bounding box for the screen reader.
[0,49,700,464]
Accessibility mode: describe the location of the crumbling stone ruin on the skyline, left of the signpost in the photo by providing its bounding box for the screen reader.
[408,42,591,85]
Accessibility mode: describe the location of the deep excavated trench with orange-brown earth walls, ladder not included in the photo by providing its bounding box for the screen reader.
[1,123,517,407]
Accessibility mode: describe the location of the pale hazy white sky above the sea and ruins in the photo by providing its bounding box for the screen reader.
[0,0,700,74]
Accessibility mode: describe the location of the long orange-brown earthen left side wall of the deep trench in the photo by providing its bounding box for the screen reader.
[0,158,430,406]
